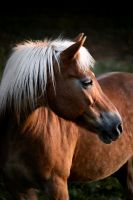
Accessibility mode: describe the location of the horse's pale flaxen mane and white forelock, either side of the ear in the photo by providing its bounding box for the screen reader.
[0,38,94,113]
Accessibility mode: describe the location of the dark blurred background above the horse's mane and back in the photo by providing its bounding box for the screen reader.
[0,0,133,74]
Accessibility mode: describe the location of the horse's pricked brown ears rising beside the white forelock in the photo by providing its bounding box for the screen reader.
[61,34,86,59]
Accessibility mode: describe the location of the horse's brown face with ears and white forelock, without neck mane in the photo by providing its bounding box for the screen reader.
[47,34,122,143]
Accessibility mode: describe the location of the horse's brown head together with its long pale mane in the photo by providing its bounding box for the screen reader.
[0,34,122,143]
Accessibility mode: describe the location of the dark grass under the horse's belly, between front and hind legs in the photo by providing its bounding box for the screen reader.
[69,177,124,200]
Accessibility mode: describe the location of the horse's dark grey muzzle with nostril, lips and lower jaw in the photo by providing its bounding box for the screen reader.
[80,112,123,144]
